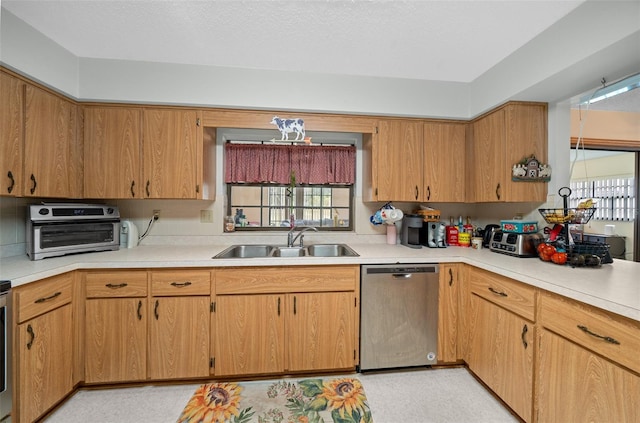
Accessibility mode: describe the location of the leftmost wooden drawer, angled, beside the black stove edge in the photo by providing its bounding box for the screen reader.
[13,273,73,323]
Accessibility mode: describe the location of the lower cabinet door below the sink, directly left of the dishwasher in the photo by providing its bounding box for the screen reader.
[287,292,356,372]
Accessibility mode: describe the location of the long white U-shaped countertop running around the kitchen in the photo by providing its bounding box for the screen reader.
[0,244,640,321]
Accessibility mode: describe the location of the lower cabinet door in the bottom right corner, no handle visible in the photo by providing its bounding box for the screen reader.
[538,330,640,423]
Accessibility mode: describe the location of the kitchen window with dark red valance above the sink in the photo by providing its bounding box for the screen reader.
[225,142,356,231]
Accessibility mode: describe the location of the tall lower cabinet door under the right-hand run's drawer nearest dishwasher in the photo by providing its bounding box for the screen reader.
[468,295,535,422]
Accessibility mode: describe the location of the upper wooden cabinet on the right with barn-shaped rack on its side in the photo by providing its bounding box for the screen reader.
[467,103,547,202]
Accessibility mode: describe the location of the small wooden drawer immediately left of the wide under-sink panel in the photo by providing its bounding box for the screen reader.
[151,270,211,297]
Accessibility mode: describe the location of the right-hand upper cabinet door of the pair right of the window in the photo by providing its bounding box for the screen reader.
[422,122,467,203]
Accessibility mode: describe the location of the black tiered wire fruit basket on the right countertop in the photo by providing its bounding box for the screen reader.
[538,187,613,267]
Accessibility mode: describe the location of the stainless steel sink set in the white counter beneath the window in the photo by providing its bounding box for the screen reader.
[213,244,359,259]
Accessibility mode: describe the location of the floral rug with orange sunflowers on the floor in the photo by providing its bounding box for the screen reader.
[178,377,373,423]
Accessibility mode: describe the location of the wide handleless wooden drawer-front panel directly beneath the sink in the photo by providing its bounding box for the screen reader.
[214,266,360,295]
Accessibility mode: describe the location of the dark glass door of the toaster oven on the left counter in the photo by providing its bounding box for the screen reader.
[29,220,120,260]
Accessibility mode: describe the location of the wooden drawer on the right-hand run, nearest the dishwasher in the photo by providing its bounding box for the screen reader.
[469,268,536,322]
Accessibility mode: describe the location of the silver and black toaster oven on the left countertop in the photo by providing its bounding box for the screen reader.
[27,203,120,260]
